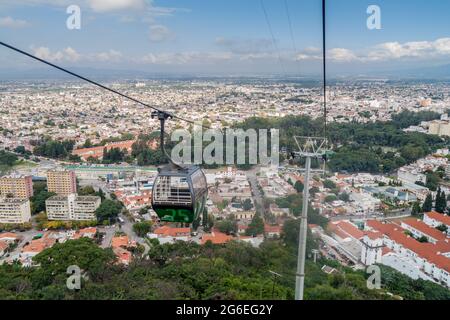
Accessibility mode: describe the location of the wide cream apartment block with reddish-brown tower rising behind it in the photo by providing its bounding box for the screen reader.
[45,194,101,221]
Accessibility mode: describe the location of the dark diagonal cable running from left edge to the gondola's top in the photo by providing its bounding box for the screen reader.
[0,41,211,129]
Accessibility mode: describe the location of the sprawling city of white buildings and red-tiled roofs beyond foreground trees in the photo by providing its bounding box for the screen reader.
[0,79,450,299]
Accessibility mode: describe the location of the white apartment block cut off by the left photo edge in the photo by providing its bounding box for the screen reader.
[0,198,31,224]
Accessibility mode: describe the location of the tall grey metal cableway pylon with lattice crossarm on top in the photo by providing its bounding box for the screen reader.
[294,137,327,300]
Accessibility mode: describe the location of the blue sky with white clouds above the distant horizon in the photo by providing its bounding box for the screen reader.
[0,0,450,75]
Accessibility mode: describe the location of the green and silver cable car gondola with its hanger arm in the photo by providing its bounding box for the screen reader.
[152,111,208,223]
